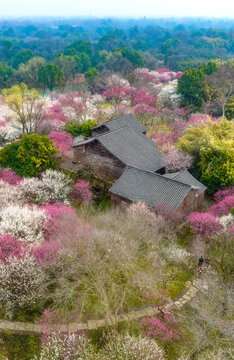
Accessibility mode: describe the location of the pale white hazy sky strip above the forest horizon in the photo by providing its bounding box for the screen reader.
[0,0,234,18]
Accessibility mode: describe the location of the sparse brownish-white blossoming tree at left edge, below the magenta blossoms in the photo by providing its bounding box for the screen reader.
[0,254,43,317]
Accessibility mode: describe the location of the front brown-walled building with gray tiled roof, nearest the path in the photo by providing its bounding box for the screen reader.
[109,166,206,214]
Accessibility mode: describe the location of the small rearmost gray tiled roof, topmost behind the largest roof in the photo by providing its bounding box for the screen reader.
[93,114,148,133]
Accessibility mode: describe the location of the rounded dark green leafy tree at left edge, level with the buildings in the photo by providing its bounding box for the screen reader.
[0,134,57,177]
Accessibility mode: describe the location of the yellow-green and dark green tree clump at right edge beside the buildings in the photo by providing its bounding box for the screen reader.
[177,119,234,193]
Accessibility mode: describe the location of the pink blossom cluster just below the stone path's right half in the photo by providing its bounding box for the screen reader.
[142,312,181,342]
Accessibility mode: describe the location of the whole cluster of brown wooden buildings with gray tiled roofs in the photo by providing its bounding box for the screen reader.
[72,115,206,214]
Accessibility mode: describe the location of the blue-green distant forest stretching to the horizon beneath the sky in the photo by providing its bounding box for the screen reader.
[0,18,234,88]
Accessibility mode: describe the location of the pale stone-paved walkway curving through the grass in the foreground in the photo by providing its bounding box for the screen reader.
[0,279,201,334]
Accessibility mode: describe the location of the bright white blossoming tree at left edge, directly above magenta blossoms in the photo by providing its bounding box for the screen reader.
[0,204,46,243]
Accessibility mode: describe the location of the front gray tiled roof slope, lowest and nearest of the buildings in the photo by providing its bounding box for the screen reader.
[109,166,191,208]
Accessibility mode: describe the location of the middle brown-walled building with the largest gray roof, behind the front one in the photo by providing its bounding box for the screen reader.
[73,125,165,180]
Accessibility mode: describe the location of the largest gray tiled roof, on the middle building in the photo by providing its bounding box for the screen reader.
[73,126,163,172]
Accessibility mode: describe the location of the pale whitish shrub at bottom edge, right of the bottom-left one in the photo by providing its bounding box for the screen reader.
[100,333,164,360]
